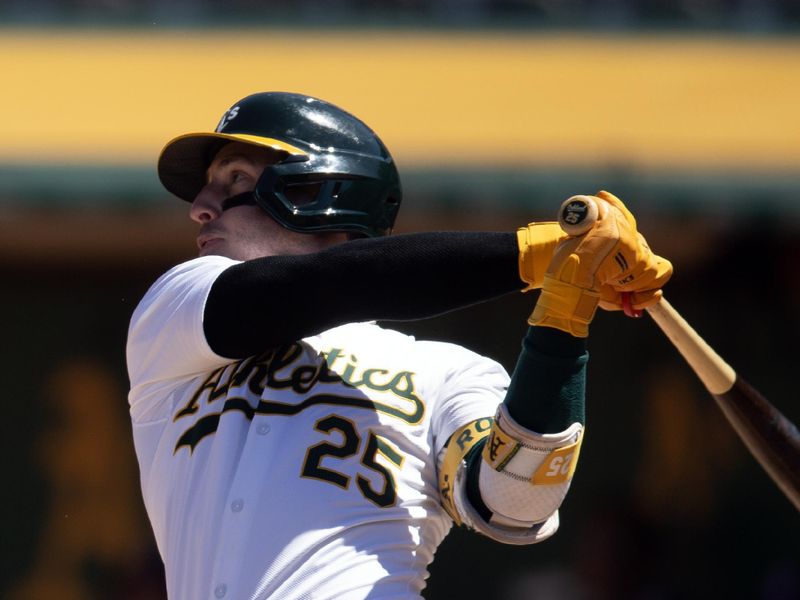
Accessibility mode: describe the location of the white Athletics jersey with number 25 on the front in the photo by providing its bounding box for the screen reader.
[127,256,508,600]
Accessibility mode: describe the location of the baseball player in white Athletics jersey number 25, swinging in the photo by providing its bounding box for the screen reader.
[127,92,671,600]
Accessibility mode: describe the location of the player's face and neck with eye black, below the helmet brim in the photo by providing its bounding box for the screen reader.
[189,142,347,260]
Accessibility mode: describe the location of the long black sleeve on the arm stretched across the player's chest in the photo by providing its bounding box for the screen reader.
[203,232,524,358]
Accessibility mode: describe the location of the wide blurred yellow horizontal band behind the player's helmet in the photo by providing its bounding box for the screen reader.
[0,29,800,171]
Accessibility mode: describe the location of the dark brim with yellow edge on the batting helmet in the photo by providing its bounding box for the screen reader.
[158,132,308,202]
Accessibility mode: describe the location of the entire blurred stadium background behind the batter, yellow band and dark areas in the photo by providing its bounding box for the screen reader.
[0,0,800,600]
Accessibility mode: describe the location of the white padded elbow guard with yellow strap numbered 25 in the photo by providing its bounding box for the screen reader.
[479,405,584,527]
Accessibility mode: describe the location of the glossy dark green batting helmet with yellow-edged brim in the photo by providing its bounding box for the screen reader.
[158,92,402,237]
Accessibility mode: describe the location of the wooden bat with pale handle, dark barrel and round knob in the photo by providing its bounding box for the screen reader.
[558,196,800,511]
